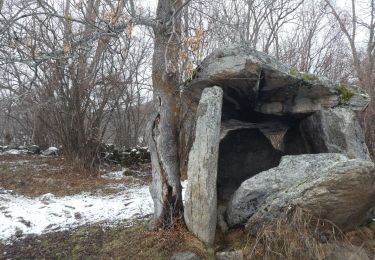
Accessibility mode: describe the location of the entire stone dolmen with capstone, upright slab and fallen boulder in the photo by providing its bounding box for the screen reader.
[184,46,375,246]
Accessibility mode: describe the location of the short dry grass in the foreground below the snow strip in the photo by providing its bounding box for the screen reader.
[0,218,214,260]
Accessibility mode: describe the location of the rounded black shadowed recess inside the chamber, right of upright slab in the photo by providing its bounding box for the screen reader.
[218,129,281,196]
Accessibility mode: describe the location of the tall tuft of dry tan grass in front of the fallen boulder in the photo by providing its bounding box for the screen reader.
[245,208,375,259]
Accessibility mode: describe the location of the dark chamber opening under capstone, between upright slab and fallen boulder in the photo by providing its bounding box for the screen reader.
[217,87,308,205]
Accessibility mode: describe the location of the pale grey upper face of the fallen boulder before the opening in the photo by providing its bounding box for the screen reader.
[227,154,347,226]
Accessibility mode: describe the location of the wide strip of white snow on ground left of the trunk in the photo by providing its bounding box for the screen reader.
[0,173,187,243]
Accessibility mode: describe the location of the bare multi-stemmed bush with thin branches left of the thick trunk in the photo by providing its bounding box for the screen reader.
[0,0,153,168]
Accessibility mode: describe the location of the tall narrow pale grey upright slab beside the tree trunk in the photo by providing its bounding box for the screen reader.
[184,87,223,244]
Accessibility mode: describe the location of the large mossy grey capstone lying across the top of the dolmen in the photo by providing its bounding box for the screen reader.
[189,45,370,116]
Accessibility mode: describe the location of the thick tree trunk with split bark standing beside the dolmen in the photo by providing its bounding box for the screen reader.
[148,0,182,228]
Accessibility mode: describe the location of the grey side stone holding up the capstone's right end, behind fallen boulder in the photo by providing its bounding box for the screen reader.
[284,108,371,160]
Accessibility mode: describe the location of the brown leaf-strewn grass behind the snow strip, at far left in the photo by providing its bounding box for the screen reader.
[0,156,149,196]
